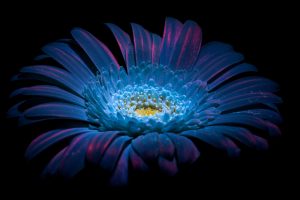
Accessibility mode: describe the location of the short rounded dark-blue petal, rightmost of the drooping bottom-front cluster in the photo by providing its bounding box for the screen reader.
[165,133,200,164]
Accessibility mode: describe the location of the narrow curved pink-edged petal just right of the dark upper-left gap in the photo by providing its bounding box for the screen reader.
[106,24,136,68]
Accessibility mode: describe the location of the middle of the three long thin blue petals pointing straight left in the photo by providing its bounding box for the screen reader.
[10,85,85,107]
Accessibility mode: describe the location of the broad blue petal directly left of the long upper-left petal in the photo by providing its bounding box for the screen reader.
[43,43,95,83]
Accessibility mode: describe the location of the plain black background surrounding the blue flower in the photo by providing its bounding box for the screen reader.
[0,1,299,198]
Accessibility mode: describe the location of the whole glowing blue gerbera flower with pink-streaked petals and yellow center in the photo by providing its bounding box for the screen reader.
[9,18,281,185]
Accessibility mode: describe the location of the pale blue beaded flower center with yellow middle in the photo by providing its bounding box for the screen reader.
[112,85,183,120]
